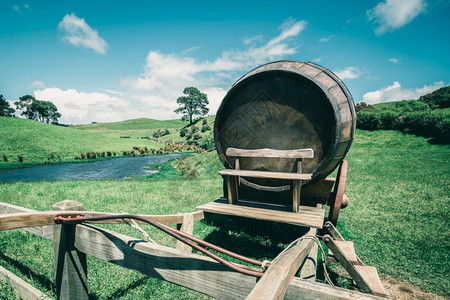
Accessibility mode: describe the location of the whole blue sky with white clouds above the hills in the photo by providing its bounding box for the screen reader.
[0,0,450,124]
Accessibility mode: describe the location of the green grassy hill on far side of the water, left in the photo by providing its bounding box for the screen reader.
[0,117,161,168]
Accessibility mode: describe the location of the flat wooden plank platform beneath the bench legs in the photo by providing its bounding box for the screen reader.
[197,201,325,228]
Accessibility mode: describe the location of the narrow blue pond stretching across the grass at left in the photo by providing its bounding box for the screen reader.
[0,154,187,182]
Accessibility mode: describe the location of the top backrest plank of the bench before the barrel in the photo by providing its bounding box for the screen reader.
[226,148,314,158]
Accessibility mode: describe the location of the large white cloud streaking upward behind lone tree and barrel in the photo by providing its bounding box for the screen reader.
[120,19,306,119]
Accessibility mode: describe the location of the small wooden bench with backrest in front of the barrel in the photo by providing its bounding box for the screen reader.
[219,148,314,213]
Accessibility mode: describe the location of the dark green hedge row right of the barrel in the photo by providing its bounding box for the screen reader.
[356,109,450,144]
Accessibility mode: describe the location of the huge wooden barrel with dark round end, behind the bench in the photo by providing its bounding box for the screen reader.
[214,61,356,191]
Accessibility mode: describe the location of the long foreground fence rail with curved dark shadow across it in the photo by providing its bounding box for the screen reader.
[75,225,380,299]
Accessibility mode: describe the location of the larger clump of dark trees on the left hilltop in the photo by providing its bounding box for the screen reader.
[15,95,61,124]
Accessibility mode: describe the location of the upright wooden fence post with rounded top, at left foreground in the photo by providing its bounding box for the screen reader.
[52,200,89,300]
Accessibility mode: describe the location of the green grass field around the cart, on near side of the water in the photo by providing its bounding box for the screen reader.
[0,124,450,299]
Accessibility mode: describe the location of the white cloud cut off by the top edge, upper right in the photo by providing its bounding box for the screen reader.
[367,0,427,35]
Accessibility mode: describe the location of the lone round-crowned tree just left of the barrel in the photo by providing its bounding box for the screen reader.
[174,87,209,126]
